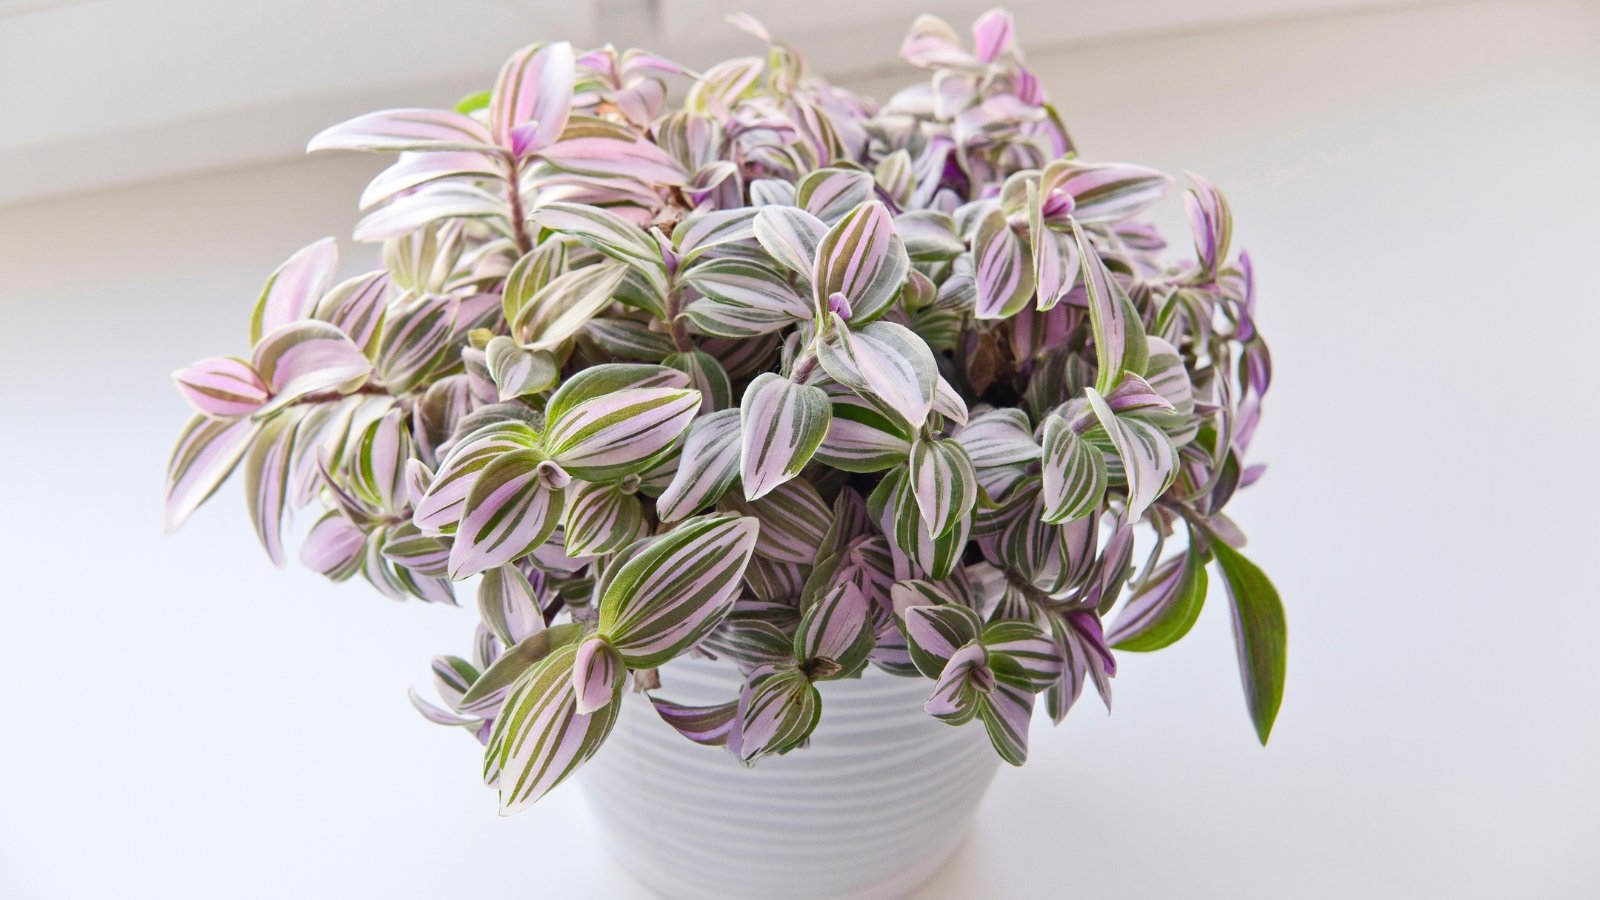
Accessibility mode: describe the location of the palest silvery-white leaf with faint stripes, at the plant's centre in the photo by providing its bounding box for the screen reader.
[818,315,939,429]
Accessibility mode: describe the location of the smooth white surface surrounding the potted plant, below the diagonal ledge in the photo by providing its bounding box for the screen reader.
[0,2,1600,900]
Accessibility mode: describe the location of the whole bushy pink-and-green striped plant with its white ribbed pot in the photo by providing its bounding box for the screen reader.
[166,11,1285,897]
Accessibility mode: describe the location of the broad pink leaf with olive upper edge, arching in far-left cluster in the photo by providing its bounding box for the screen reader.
[251,320,373,415]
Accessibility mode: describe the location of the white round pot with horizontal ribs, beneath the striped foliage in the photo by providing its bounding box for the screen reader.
[578,650,1000,900]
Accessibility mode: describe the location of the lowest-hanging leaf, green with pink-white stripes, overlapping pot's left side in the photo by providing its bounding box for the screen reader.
[485,644,622,815]
